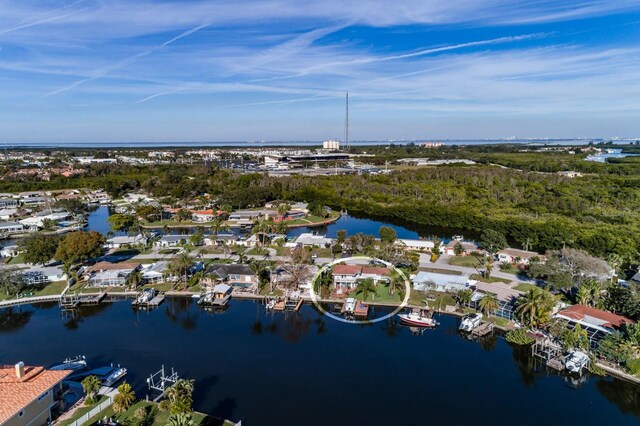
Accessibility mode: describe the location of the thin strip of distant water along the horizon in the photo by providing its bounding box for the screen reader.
[3,139,604,149]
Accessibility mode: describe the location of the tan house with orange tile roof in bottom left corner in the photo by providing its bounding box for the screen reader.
[0,362,72,426]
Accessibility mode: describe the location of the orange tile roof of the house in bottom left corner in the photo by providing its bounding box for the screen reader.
[0,365,72,424]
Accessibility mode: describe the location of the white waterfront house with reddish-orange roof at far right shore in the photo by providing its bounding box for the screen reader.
[554,305,634,349]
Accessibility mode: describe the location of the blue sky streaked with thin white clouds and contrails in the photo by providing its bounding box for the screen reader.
[0,0,640,143]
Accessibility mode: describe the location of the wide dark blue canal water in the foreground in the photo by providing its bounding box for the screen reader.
[0,298,640,426]
